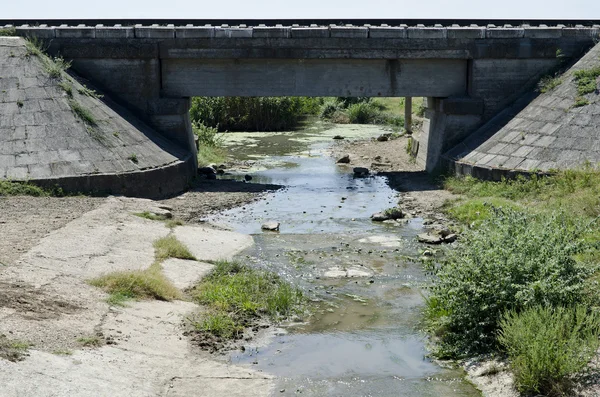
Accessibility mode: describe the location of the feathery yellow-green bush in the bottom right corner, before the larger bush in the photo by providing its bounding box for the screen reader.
[498,305,600,396]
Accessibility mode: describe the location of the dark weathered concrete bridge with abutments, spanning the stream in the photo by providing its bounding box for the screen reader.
[4,21,600,170]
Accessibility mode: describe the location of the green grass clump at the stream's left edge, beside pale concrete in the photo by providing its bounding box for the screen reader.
[191,261,304,338]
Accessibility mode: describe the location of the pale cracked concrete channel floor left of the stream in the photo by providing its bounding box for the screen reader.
[0,198,272,397]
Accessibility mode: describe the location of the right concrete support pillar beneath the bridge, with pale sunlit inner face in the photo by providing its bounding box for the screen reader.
[412,97,483,172]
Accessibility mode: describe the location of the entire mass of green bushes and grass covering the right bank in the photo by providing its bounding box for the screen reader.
[426,169,600,395]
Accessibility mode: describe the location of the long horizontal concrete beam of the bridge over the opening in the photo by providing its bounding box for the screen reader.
[161,59,467,97]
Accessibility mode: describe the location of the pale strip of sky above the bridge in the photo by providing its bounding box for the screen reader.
[0,0,600,20]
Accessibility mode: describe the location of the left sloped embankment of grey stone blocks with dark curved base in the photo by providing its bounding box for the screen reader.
[0,37,195,196]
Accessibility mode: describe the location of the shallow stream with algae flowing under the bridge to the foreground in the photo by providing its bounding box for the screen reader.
[209,124,481,397]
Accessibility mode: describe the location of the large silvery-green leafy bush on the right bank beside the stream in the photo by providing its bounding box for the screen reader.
[426,208,594,357]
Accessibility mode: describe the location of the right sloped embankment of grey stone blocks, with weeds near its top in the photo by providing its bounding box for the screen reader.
[445,45,600,179]
